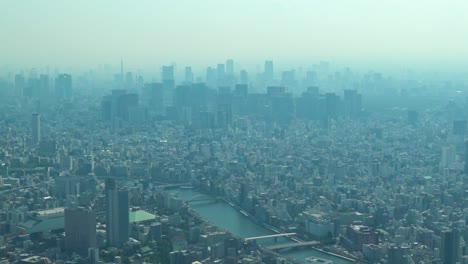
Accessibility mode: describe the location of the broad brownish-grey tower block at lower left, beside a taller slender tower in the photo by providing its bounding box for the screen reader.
[65,207,96,256]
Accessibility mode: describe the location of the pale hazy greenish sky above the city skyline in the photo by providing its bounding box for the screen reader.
[0,0,468,68]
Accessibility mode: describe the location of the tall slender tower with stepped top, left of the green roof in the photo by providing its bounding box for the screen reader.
[106,179,130,247]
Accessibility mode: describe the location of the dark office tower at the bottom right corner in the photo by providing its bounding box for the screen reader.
[440,229,460,264]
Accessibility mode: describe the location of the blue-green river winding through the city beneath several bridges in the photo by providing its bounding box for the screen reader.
[171,189,353,264]
